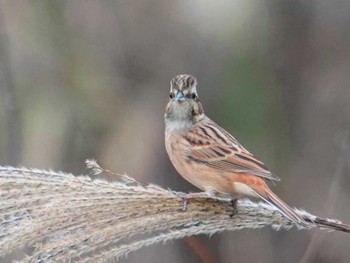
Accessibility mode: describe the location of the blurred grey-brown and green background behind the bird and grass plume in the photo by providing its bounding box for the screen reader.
[0,0,350,263]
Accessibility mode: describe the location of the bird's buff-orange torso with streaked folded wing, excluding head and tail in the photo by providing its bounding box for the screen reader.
[165,117,279,200]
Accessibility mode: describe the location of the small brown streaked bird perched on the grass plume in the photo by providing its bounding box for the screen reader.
[164,75,307,226]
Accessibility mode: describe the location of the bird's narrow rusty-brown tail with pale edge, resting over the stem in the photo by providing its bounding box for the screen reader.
[257,190,309,227]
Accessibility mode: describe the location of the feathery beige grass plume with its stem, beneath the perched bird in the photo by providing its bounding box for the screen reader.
[0,161,350,262]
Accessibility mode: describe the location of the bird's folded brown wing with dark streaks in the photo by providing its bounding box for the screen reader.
[185,119,280,181]
